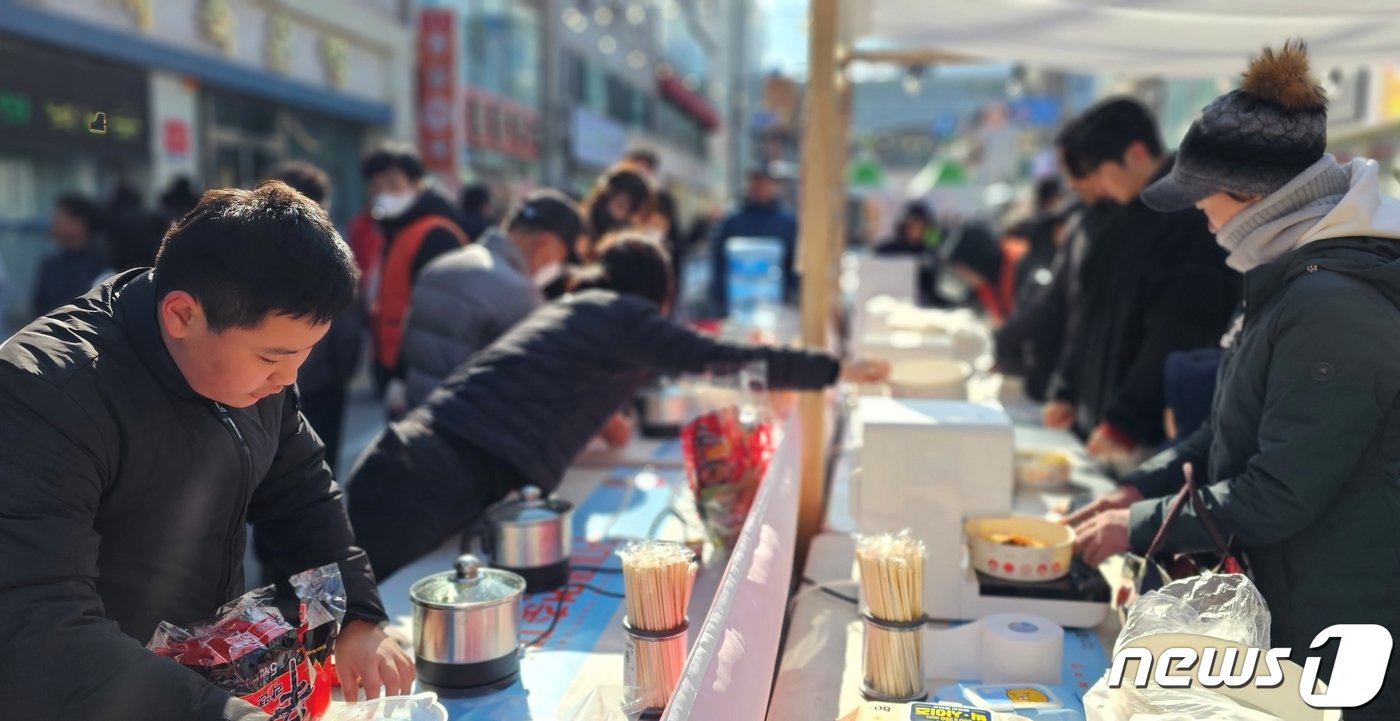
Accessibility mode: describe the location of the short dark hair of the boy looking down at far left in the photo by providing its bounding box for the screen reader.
[155,181,360,332]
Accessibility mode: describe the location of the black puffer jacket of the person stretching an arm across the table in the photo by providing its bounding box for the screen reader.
[414,290,840,490]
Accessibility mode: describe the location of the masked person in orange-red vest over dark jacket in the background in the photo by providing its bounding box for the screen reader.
[361,143,469,416]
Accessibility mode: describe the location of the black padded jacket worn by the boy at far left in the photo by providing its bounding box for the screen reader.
[0,270,385,721]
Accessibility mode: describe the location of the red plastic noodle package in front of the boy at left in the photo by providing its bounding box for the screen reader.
[146,564,346,721]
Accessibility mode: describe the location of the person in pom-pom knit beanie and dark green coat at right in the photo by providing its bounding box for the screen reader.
[1067,41,1400,721]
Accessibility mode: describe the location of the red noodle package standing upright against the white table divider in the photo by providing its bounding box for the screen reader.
[680,406,774,549]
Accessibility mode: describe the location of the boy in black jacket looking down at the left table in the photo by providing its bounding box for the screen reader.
[0,182,413,721]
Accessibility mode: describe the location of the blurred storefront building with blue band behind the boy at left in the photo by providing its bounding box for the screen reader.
[0,0,413,327]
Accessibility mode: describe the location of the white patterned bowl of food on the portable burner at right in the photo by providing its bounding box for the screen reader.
[963,517,1074,584]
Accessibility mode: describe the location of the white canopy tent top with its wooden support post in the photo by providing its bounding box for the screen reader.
[797,0,1400,568]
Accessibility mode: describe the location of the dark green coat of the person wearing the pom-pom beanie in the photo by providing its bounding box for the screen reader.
[1126,238,1400,705]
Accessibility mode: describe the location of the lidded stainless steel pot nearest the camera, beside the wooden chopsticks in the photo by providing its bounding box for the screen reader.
[409,554,525,689]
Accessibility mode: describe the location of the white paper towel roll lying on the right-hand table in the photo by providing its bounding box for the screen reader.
[924,613,1064,686]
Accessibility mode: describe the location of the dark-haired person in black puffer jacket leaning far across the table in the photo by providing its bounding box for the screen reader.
[346,235,889,578]
